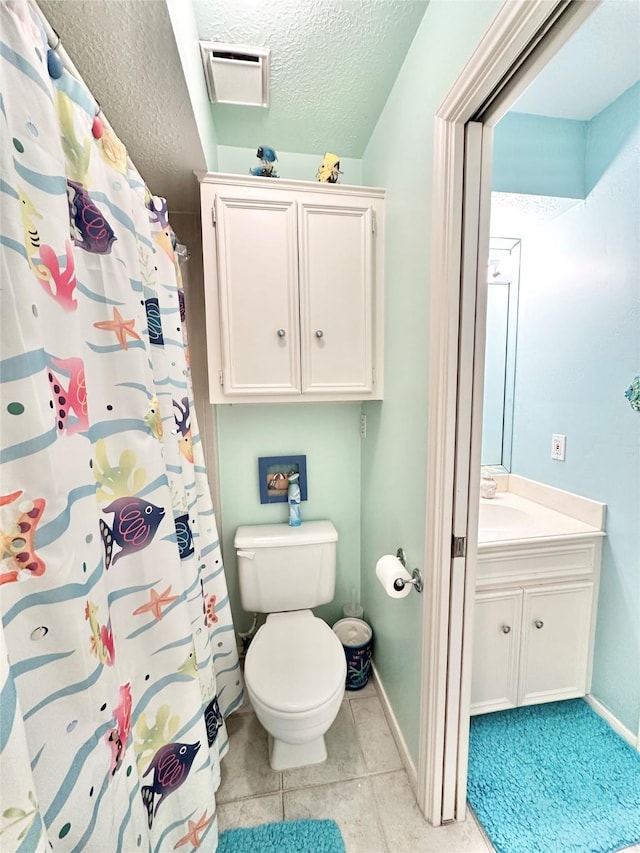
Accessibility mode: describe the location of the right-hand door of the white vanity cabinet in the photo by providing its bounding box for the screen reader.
[518,583,593,705]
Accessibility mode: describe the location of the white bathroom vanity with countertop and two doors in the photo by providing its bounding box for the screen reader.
[471,475,606,714]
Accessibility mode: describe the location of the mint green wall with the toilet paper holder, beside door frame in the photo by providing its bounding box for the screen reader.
[362,0,501,763]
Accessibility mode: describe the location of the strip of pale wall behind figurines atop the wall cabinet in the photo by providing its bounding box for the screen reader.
[218,145,362,186]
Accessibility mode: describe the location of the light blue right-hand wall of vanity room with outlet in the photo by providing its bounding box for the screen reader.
[512,91,640,735]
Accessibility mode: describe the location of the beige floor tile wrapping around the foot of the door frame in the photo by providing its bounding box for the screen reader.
[370,771,491,853]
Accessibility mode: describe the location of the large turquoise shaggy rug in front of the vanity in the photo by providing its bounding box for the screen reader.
[468,699,640,853]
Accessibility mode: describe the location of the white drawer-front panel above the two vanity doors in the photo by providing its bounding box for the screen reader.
[476,537,602,589]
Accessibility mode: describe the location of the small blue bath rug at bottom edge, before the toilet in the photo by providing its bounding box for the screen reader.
[217,820,345,853]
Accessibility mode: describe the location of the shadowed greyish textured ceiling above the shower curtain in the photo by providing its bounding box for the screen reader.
[38,0,206,210]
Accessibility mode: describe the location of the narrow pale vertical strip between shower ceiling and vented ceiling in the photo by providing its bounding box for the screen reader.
[166,0,218,172]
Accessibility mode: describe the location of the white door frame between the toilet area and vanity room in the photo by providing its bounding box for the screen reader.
[417,0,599,826]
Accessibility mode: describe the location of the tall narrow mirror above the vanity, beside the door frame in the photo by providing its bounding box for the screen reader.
[481,237,520,472]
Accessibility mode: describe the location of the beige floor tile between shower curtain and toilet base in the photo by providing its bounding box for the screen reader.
[216,714,281,803]
